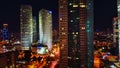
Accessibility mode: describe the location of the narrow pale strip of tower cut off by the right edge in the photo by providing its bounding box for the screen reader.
[117,0,120,61]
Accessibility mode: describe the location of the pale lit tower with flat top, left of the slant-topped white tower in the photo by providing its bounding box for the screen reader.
[20,5,33,49]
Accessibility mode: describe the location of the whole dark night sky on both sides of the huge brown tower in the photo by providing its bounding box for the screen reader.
[0,0,117,32]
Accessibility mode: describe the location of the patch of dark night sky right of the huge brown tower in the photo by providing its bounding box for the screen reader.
[94,0,117,30]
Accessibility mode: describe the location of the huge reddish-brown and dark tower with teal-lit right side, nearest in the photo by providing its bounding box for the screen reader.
[59,0,93,68]
